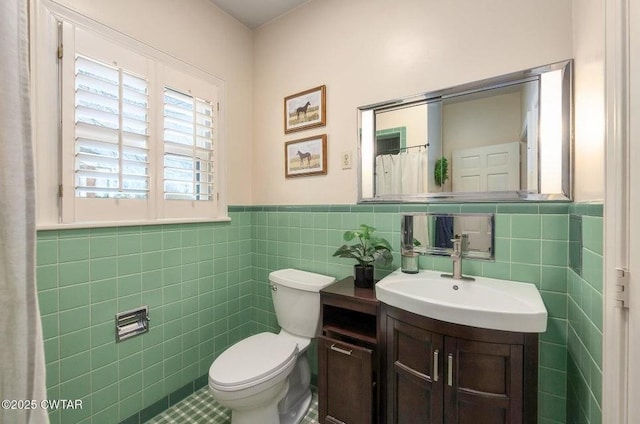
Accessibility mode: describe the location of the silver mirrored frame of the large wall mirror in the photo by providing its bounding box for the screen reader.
[358,59,574,203]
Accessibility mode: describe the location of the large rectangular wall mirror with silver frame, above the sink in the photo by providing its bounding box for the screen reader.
[358,61,573,202]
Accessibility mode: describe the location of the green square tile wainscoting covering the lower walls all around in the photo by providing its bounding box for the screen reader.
[37,203,602,424]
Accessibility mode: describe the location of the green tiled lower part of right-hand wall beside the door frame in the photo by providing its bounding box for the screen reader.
[567,204,603,424]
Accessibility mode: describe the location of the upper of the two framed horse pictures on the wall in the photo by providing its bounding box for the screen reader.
[284,85,327,134]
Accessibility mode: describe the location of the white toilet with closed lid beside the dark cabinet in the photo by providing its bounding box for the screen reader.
[209,269,335,424]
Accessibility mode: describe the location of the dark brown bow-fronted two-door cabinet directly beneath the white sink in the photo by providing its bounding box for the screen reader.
[381,304,538,424]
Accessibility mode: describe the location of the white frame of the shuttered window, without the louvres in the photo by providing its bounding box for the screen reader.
[30,0,230,229]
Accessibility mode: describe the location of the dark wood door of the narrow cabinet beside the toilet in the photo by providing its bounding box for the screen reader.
[318,336,375,424]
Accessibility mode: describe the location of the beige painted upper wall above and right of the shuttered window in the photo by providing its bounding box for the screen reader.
[54,0,253,205]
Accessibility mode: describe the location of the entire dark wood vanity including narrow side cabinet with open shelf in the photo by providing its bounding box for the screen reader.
[318,277,538,424]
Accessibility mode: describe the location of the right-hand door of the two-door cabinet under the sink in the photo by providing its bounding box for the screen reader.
[444,337,523,424]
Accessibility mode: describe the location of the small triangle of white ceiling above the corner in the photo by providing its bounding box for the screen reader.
[211,0,309,29]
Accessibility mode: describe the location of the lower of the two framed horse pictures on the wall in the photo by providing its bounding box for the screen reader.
[284,134,327,178]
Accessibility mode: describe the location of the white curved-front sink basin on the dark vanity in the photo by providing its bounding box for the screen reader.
[376,270,547,333]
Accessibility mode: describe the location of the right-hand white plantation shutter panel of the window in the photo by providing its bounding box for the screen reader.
[157,66,219,219]
